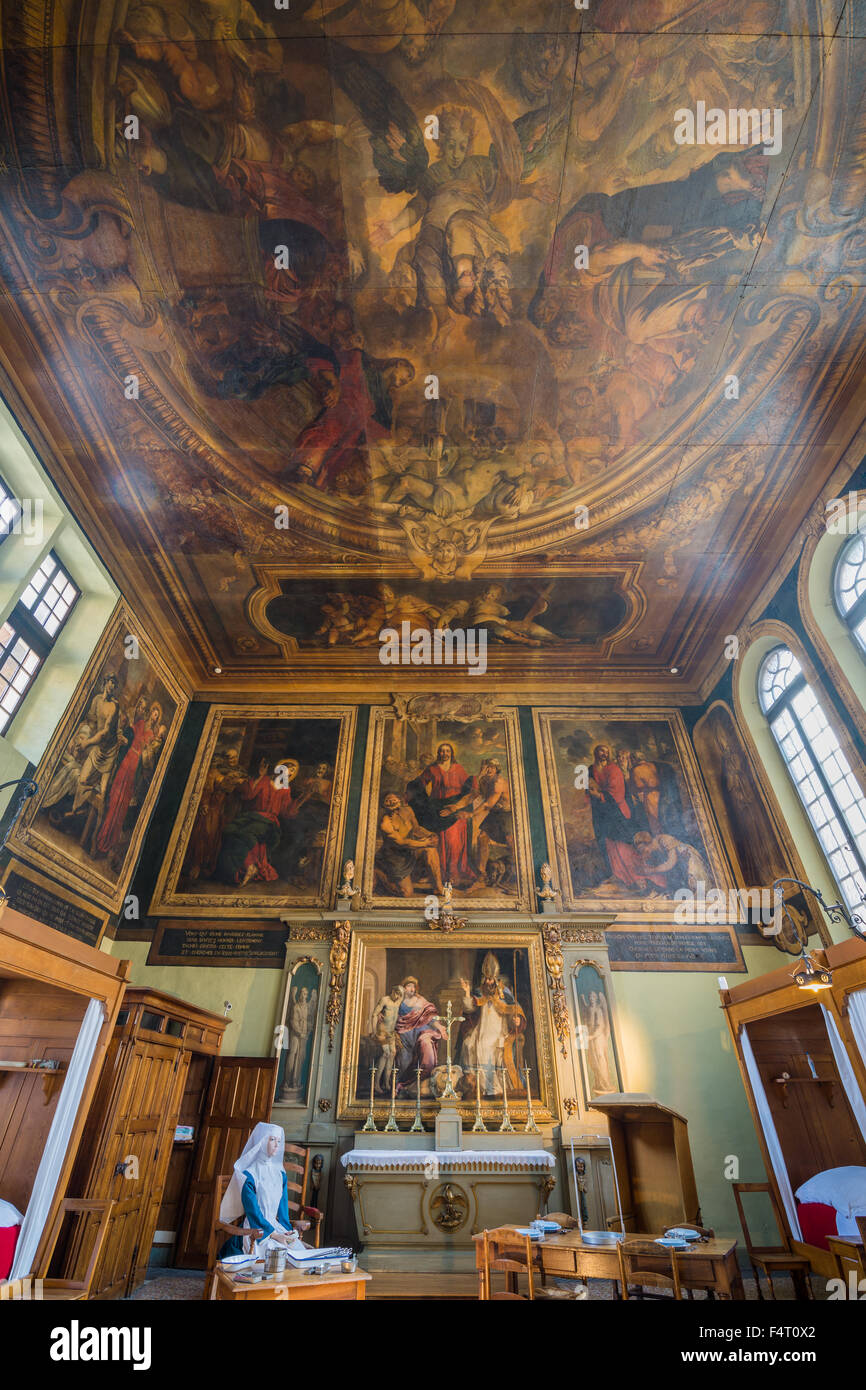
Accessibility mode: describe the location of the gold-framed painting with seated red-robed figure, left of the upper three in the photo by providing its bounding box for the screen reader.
[150,705,356,917]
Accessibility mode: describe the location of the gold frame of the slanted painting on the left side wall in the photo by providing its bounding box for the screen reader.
[8,602,189,913]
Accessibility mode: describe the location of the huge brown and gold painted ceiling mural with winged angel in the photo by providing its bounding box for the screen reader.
[0,0,866,682]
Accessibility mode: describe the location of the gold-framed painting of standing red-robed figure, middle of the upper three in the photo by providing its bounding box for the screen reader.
[356,701,531,909]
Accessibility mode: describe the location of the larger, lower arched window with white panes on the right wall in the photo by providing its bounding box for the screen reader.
[758,646,866,909]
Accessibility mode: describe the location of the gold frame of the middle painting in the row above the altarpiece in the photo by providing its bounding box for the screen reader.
[354,705,532,912]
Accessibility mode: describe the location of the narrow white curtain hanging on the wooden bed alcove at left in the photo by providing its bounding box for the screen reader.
[10,999,104,1279]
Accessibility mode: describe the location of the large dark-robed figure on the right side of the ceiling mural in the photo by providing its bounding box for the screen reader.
[530,150,767,406]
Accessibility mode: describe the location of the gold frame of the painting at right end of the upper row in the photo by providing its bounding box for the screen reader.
[532,705,730,923]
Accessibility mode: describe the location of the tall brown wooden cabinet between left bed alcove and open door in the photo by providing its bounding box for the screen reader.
[64,988,225,1298]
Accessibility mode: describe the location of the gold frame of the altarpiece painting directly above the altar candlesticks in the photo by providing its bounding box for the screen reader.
[336,923,559,1131]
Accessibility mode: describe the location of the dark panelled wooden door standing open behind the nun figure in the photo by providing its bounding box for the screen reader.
[175,1056,278,1269]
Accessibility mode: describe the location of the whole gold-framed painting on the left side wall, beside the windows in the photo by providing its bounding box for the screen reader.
[8,603,186,912]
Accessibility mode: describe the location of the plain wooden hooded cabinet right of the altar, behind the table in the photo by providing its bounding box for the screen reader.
[591,1094,701,1232]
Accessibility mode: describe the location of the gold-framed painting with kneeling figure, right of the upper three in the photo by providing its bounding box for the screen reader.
[532,708,730,913]
